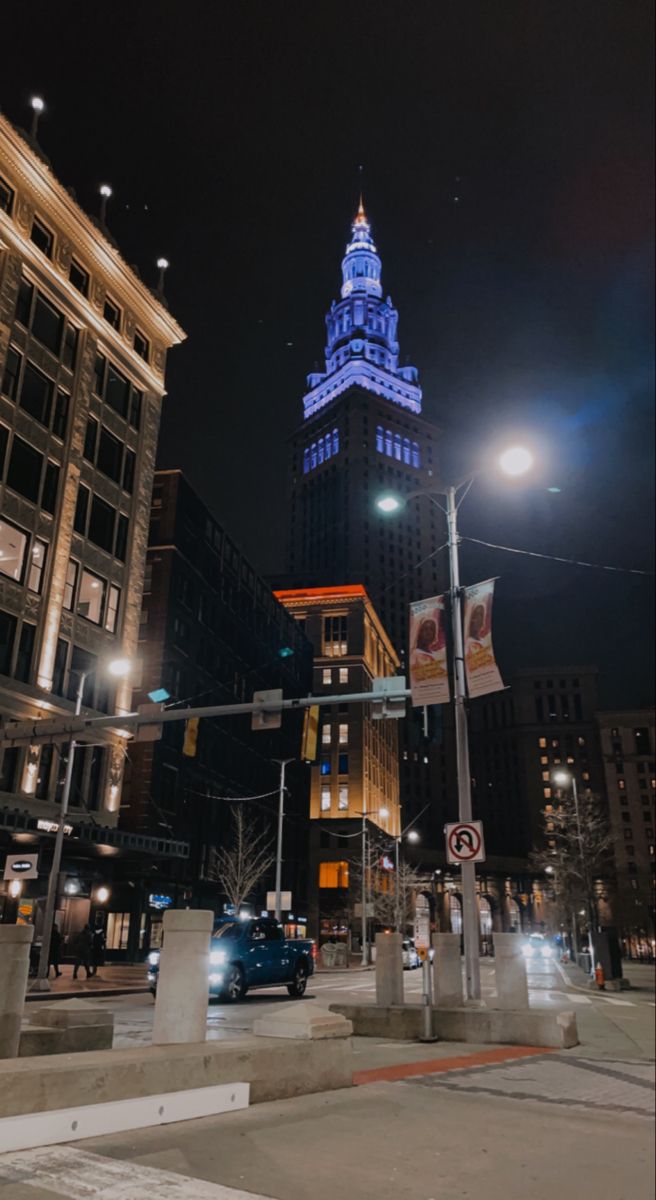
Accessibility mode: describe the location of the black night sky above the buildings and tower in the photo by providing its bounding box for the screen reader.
[0,0,654,707]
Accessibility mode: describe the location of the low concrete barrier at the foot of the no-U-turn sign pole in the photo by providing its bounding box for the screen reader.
[330,1004,578,1050]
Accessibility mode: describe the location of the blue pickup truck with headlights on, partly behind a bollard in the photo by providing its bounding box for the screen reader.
[148,917,315,1001]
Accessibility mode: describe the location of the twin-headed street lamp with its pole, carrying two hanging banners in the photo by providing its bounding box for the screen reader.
[375,446,534,1000]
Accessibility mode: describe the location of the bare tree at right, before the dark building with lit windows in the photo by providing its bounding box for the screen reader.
[530,792,613,950]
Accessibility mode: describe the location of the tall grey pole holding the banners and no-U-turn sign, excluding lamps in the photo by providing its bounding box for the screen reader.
[446,487,481,1000]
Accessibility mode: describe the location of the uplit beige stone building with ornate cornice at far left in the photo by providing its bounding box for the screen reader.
[0,116,185,926]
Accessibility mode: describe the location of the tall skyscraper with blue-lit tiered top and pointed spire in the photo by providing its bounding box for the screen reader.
[287,203,444,835]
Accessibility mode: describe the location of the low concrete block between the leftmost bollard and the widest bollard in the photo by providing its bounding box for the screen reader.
[19,1000,114,1058]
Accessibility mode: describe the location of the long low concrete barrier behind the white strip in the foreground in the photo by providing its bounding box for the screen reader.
[0,1037,353,1118]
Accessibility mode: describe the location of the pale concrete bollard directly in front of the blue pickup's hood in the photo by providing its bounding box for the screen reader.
[152,908,215,1045]
